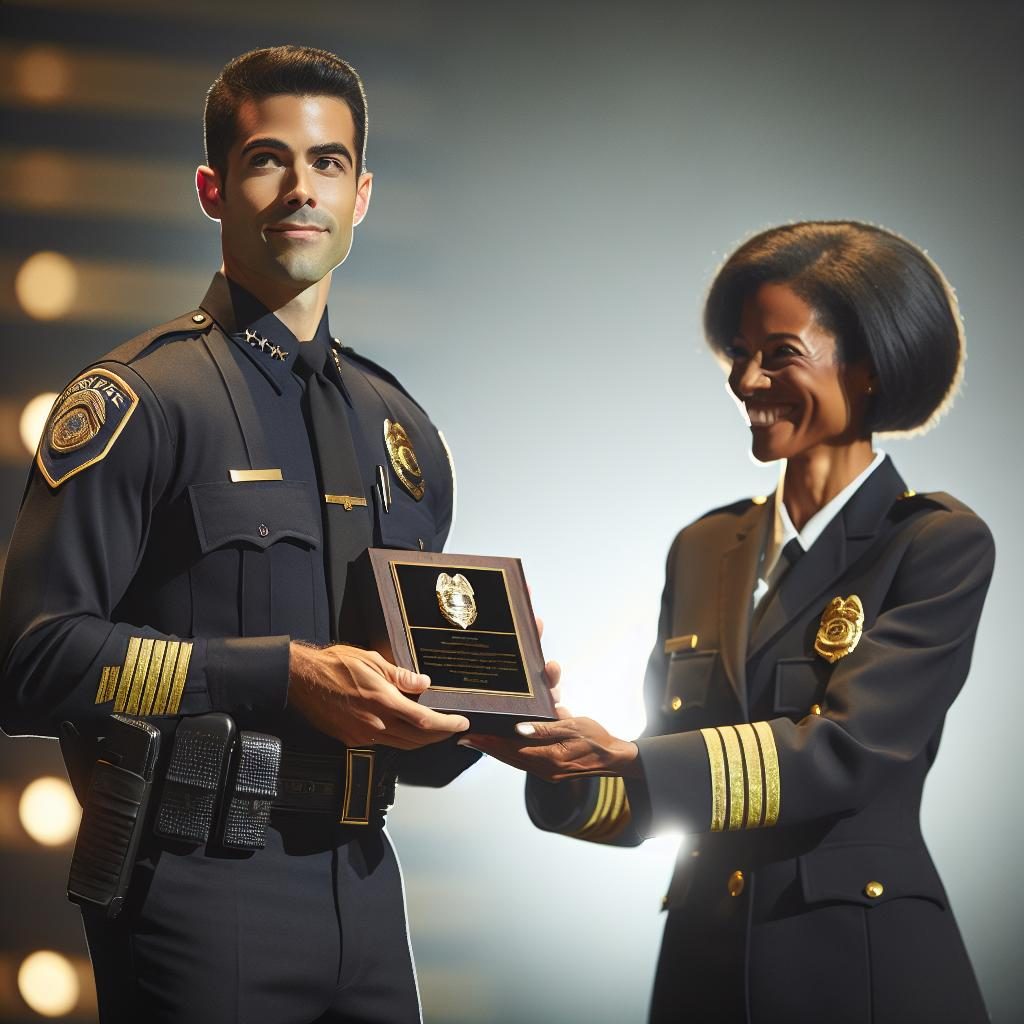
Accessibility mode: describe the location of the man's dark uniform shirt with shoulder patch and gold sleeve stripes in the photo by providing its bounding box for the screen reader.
[0,274,472,784]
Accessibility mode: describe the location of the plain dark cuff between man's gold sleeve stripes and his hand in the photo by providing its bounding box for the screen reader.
[206,636,291,712]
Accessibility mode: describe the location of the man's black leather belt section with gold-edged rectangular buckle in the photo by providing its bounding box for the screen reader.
[273,748,395,825]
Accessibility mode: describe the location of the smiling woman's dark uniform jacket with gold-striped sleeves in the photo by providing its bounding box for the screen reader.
[527,459,993,1024]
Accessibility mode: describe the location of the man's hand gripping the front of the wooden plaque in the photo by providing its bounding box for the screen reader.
[288,643,469,751]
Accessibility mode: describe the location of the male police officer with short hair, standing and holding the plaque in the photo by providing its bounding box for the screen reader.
[0,46,478,1024]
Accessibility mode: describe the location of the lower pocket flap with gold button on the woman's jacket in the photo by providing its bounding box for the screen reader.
[800,843,946,909]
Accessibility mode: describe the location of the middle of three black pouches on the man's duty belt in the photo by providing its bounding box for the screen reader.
[154,712,236,845]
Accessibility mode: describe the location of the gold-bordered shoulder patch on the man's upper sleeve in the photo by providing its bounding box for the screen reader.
[36,369,138,487]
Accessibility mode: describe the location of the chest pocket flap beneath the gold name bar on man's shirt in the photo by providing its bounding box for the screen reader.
[188,480,321,554]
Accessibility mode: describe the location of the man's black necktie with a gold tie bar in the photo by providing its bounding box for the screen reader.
[295,342,373,642]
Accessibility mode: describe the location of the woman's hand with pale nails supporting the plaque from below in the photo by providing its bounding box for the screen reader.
[459,711,640,782]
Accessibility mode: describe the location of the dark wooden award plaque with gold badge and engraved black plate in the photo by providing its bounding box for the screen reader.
[346,548,557,733]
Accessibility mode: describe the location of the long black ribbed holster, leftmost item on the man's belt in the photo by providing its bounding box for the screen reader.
[68,715,160,918]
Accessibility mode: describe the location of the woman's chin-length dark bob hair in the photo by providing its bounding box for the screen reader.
[705,220,964,433]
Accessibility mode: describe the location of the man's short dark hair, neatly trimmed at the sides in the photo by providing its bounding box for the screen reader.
[203,46,367,183]
